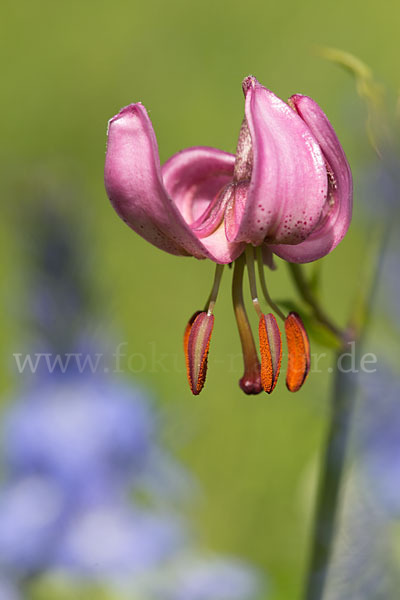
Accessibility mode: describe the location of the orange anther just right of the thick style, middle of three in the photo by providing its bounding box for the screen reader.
[258,313,282,394]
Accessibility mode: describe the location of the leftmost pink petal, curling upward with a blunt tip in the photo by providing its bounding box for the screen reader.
[105,103,241,262]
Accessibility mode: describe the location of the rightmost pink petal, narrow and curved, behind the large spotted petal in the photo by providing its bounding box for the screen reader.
[271,95,353,263]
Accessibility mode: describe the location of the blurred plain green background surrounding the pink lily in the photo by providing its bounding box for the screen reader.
[0,0,400,600]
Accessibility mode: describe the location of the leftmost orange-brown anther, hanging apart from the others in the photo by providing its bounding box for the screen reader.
[183,311,214,396]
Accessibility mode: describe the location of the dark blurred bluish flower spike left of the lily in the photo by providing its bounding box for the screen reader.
[20,199,96,352]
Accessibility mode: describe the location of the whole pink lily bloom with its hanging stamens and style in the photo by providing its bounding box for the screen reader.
[105,77,352,394]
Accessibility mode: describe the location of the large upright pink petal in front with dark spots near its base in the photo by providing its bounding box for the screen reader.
[227,77,328,245]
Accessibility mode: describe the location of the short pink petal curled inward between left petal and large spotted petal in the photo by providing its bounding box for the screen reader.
[162,146,245,263]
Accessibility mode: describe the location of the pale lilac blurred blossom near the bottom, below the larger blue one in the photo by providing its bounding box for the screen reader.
[55,504,185,580]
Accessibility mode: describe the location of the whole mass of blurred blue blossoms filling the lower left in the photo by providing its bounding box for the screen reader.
[0,377,266,600]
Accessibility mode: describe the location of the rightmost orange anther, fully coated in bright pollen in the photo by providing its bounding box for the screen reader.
[285,312,311,392]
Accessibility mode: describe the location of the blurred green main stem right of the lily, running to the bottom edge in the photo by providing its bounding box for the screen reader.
[304,223,391,600]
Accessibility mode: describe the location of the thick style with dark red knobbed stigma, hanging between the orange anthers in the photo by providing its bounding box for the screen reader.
[232,254,262,394]
